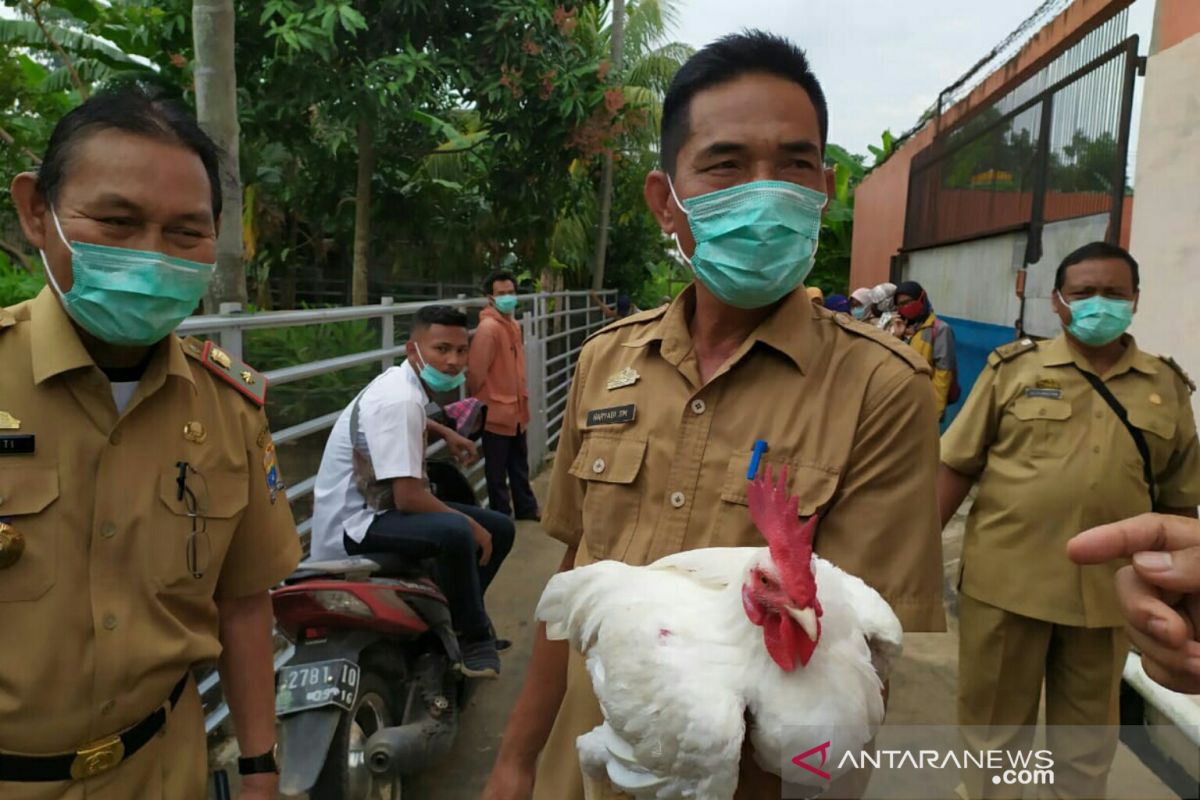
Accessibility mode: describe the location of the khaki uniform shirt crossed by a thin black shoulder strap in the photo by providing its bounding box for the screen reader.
[942,335,1200,627]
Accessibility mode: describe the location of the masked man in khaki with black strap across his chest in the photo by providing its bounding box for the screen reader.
[938,242,1200,798]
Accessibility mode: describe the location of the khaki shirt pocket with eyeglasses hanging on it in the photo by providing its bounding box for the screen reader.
[149,468,250,594]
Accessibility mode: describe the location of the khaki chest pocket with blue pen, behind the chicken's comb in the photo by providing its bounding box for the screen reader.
[707,450,840,547]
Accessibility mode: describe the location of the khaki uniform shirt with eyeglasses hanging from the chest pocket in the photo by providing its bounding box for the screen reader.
[0,289,300,799]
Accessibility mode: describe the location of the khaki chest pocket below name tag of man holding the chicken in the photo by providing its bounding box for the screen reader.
[569,433,646,561]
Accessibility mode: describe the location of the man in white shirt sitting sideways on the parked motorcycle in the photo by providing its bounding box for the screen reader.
[312,306,516,678]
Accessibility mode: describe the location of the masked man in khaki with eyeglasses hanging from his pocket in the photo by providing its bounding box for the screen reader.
[0,89,299,800]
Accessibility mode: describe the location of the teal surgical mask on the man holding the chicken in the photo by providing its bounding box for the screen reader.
[667,179,826,308]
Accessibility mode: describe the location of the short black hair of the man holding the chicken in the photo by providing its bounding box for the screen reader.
[659,30,829,175]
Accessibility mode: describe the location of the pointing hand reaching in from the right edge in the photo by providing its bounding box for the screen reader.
[1067,513,1200,694]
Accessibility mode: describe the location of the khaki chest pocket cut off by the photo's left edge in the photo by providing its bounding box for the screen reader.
[0,464,60,602]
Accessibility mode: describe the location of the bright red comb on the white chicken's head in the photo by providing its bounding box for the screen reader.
[746,465,817,601]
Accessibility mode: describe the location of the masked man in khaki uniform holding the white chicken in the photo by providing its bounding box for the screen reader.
[485,32,944,800]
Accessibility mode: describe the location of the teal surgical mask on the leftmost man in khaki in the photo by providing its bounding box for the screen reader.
[42,209,215,347]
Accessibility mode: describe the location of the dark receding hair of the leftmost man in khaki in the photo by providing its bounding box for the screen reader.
[37,83,221,218]
